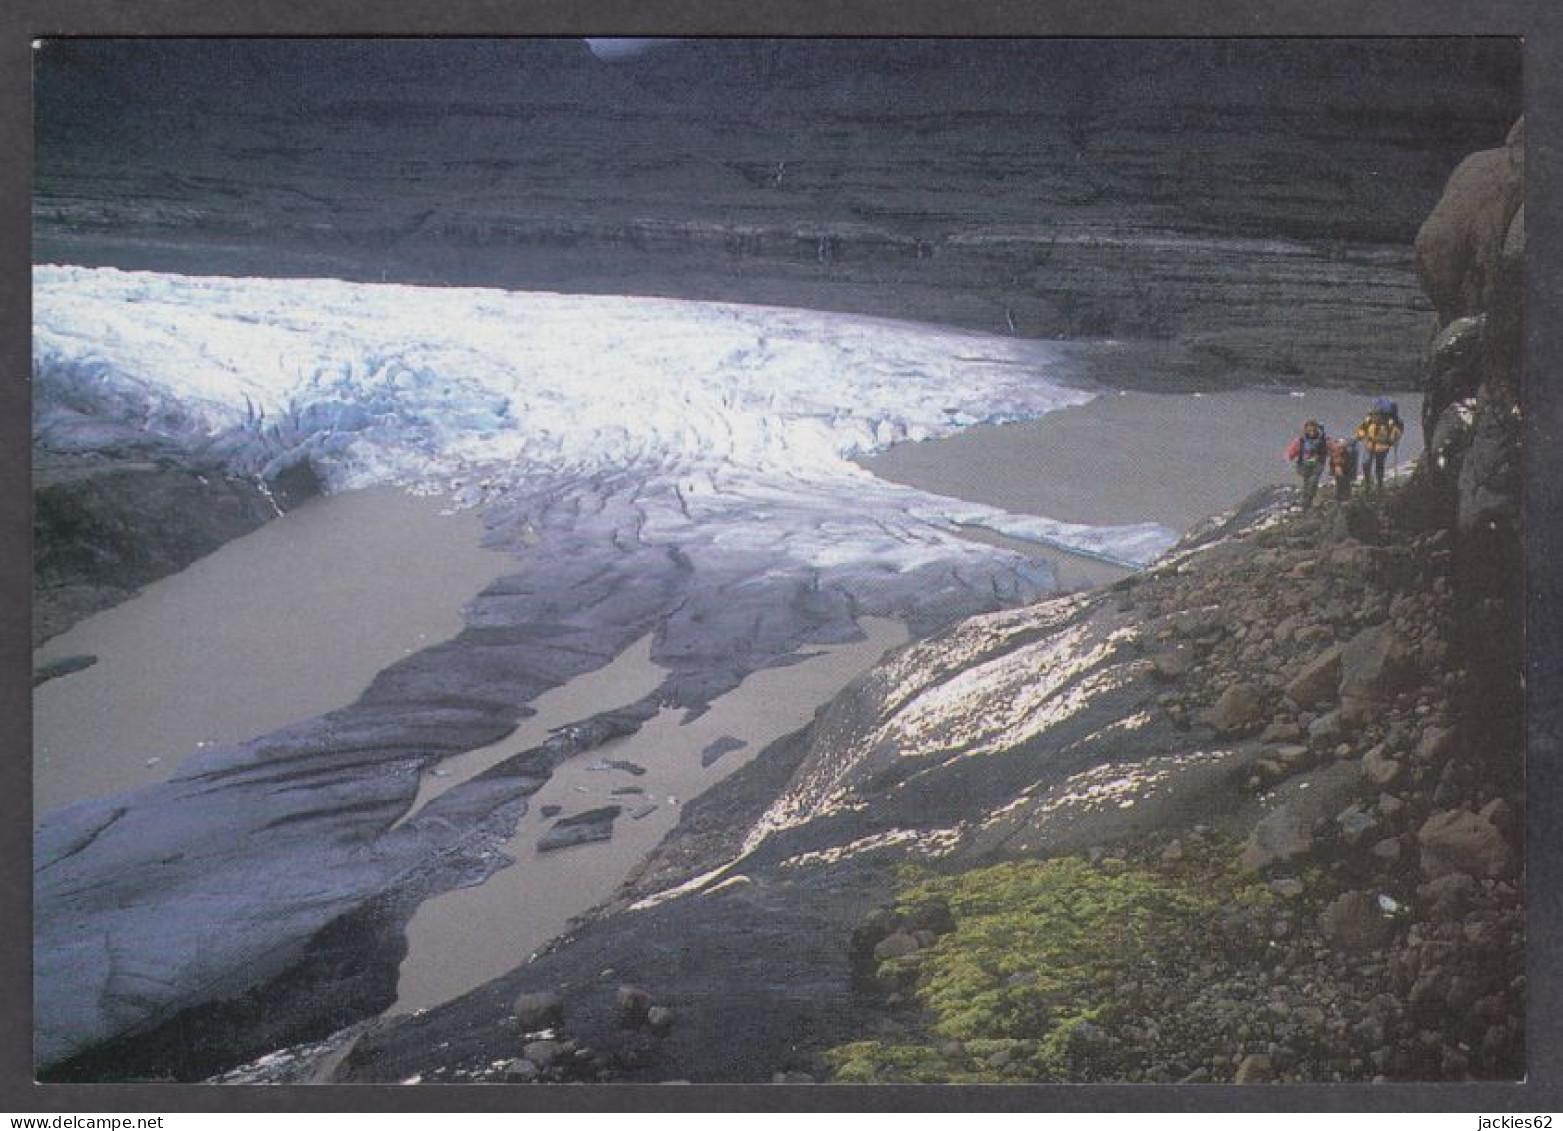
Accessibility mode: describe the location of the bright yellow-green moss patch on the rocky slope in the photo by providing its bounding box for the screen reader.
[825,848,1271,1083]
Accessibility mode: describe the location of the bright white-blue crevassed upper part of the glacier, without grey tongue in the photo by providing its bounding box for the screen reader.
[33,266,1174,570]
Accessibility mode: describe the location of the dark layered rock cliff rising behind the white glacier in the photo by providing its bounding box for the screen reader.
[34,39,1519,387]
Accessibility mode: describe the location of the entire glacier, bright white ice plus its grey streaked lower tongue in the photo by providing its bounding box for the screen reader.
[33,266,1175,1078]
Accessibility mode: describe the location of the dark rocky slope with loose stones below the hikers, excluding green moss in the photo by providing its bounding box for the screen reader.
[326,471,1524,1081]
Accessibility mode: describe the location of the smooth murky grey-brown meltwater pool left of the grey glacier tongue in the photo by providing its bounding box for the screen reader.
[33,489,514,815]
